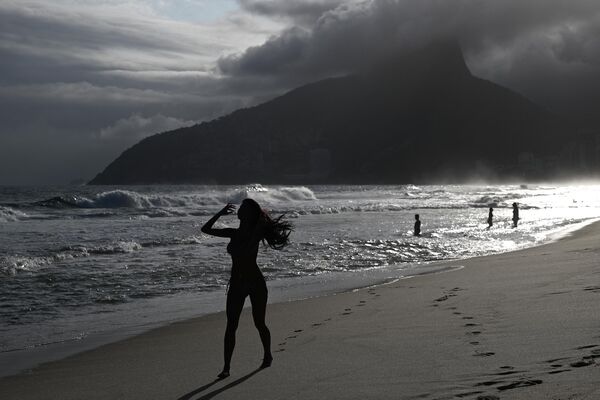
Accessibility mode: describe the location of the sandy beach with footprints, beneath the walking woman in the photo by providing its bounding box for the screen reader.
[0,223,600,400]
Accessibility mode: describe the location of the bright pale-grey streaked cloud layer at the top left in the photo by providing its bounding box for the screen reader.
[0,0,282,80]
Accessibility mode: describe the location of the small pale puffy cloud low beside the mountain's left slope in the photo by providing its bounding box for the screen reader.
[100,114,197,141]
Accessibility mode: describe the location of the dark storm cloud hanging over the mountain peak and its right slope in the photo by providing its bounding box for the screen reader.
[223,0,600,121]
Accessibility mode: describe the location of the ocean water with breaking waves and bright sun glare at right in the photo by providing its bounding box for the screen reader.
[0,184,600,364]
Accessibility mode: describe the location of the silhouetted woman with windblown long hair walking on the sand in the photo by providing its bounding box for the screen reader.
[201,199,293,379]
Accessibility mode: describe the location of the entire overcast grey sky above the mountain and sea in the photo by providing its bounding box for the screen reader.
[0,0,600,184]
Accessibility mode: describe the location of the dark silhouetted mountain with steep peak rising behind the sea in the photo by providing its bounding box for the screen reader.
[90,43,577,184]
